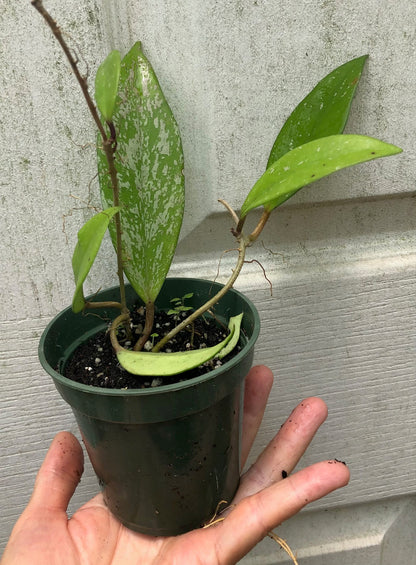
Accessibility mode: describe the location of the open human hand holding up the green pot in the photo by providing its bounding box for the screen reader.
[1,366,349,565]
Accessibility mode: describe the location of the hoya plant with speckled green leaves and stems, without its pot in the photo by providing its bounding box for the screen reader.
[32,0,401,376]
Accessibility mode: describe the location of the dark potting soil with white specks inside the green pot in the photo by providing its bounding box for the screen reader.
[64,307,240,389]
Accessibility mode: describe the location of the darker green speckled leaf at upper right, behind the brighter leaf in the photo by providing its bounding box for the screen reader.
[267,55,368,167]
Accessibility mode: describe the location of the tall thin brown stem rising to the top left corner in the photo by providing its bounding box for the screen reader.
[32,0,128,313]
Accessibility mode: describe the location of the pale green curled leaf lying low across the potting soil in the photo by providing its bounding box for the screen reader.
[117,314,243,377]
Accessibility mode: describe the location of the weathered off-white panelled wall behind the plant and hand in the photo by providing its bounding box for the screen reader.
[0,0,416,565]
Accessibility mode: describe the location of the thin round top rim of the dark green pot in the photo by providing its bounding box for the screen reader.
[38,277,260,397]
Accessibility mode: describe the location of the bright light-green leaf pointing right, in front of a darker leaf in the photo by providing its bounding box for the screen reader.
[241,135,402,218]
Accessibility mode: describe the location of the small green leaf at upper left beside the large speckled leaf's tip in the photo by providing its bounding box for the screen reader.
[95,50,121,122]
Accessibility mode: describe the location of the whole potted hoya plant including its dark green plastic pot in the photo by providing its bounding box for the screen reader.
[32,0,401,535]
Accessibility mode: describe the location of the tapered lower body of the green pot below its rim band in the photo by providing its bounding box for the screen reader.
[76,386,243,536]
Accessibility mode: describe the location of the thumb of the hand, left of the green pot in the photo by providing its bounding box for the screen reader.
[27,432,84,512]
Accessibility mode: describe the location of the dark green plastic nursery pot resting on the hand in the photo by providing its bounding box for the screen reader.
[39,278,260,536]
